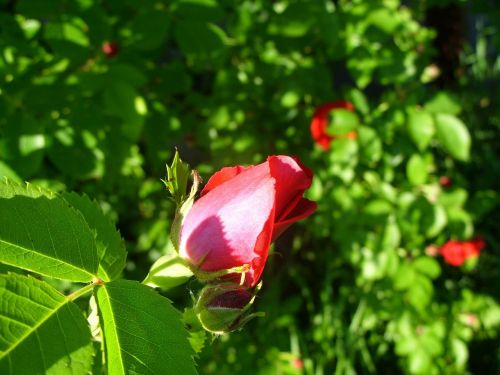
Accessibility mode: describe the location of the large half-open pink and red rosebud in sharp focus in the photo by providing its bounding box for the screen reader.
[179,155,316,287]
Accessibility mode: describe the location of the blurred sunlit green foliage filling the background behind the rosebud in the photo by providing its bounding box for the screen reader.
[0,0,500,375]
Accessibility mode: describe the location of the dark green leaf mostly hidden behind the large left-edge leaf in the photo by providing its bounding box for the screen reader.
[62,193,127,281]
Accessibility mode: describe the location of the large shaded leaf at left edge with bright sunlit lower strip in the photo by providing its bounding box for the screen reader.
[0,181,99,282]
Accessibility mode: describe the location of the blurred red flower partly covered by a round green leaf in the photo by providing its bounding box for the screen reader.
[311,101,357,150]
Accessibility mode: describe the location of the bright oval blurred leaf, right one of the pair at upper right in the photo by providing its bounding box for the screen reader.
[436,113,471,161]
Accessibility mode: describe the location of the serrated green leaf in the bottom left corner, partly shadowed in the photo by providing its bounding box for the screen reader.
[0,274,94,375]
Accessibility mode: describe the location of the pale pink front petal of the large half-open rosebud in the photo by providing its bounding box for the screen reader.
[179,163,275,283]
